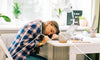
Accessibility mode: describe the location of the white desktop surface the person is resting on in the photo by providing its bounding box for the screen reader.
[47,34,100,47]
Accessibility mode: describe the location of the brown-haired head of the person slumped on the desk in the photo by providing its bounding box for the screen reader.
[43,21,59,35]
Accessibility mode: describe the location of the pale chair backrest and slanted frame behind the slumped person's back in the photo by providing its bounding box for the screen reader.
[0,33,16,60]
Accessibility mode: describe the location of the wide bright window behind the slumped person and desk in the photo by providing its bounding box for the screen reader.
[0,0,95,26]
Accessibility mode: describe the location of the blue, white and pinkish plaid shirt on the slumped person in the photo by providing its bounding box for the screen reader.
[8,22,42,60]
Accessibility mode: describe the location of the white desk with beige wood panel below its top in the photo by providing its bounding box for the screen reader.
[48,34,100,60]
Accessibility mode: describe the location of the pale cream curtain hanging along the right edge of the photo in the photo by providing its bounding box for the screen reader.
[92,0,100,33]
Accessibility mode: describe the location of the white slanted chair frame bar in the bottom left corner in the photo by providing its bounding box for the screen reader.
[0,39,13,60]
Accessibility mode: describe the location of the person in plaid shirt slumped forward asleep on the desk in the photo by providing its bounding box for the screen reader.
[8,21,59,60]
